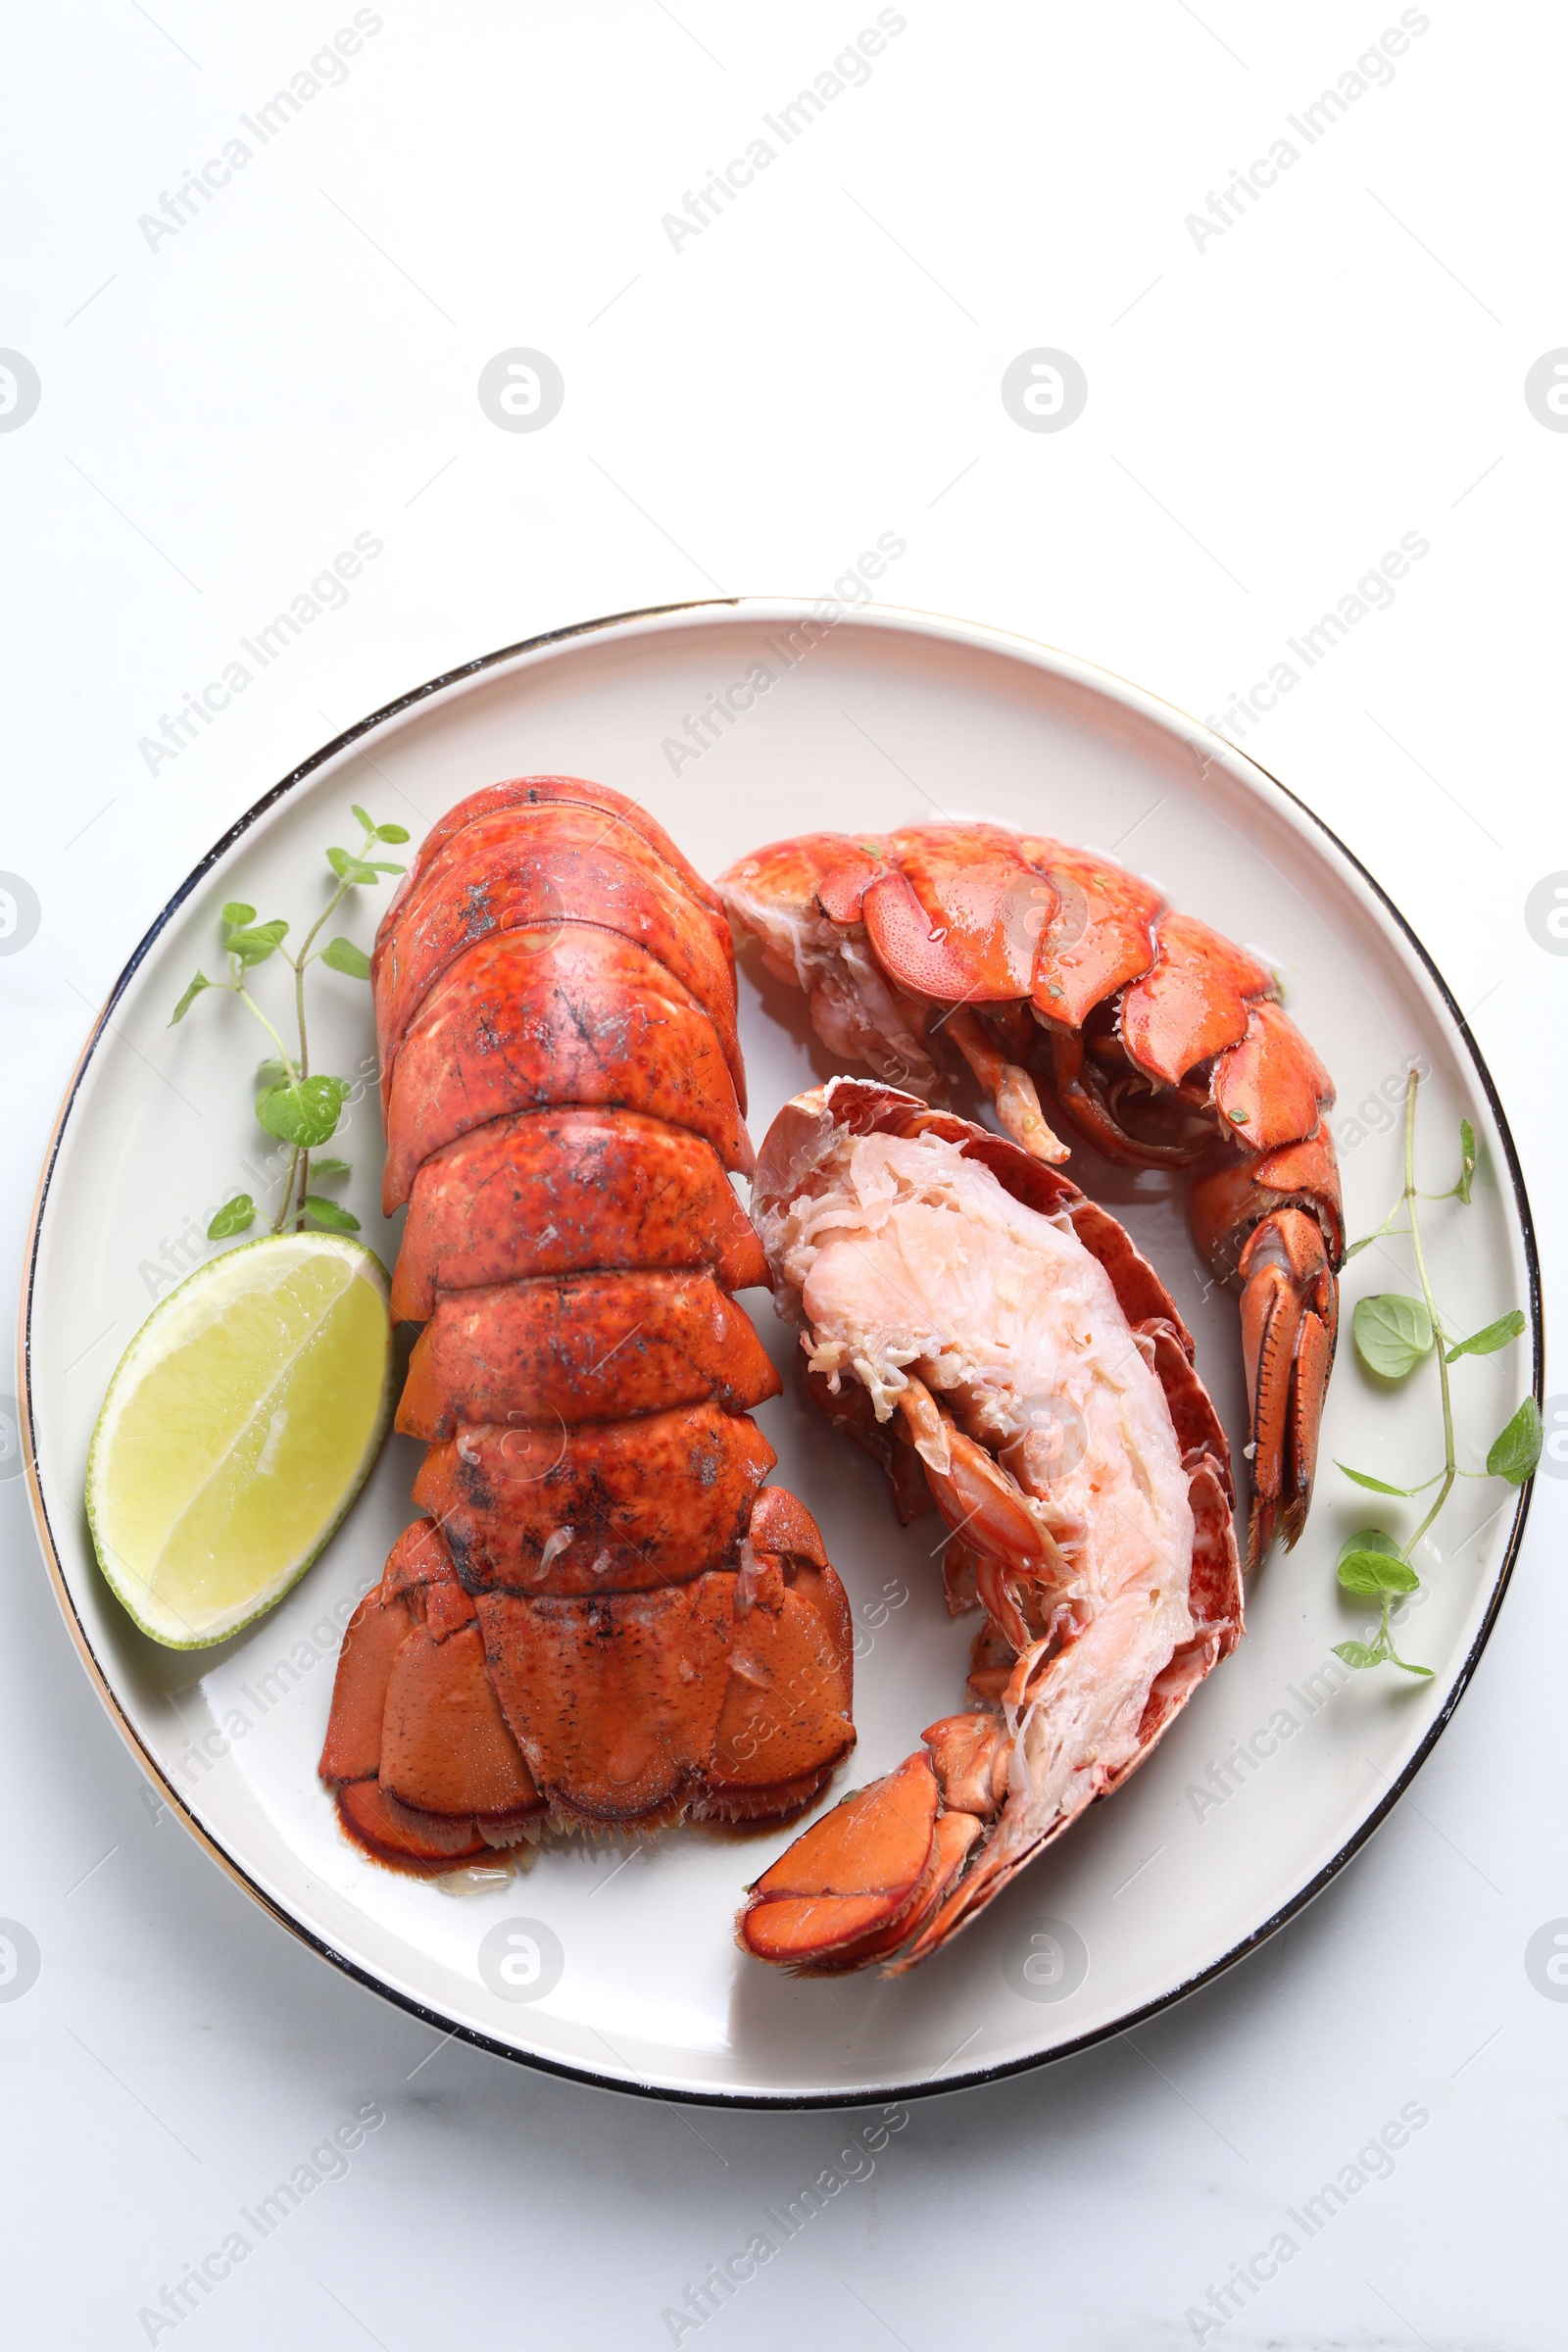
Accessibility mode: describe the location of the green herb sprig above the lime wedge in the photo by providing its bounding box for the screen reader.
[170,807,409,1242]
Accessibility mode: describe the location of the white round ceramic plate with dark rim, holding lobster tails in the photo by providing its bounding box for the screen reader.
[22,600,1540,2105]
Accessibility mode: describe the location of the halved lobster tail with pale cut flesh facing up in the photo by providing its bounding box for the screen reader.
[738,1080,1242,1974]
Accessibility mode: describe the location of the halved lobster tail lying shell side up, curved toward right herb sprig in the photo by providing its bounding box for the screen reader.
[719,823,1345,1564]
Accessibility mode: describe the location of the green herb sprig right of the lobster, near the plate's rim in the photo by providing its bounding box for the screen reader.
[1336,1070,1543,1677]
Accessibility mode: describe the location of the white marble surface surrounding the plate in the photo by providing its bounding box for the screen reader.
[0,0,1568,2352]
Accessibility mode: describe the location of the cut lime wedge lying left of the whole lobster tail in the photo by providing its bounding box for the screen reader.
[87,1233,393,1648]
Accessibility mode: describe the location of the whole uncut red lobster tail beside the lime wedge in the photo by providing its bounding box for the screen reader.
[319,776,854,1872]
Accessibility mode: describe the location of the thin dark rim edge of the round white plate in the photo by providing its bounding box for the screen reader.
[19,595,1544,2112]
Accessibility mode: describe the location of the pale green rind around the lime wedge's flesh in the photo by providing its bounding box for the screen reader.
[87,1233,395,1648]
